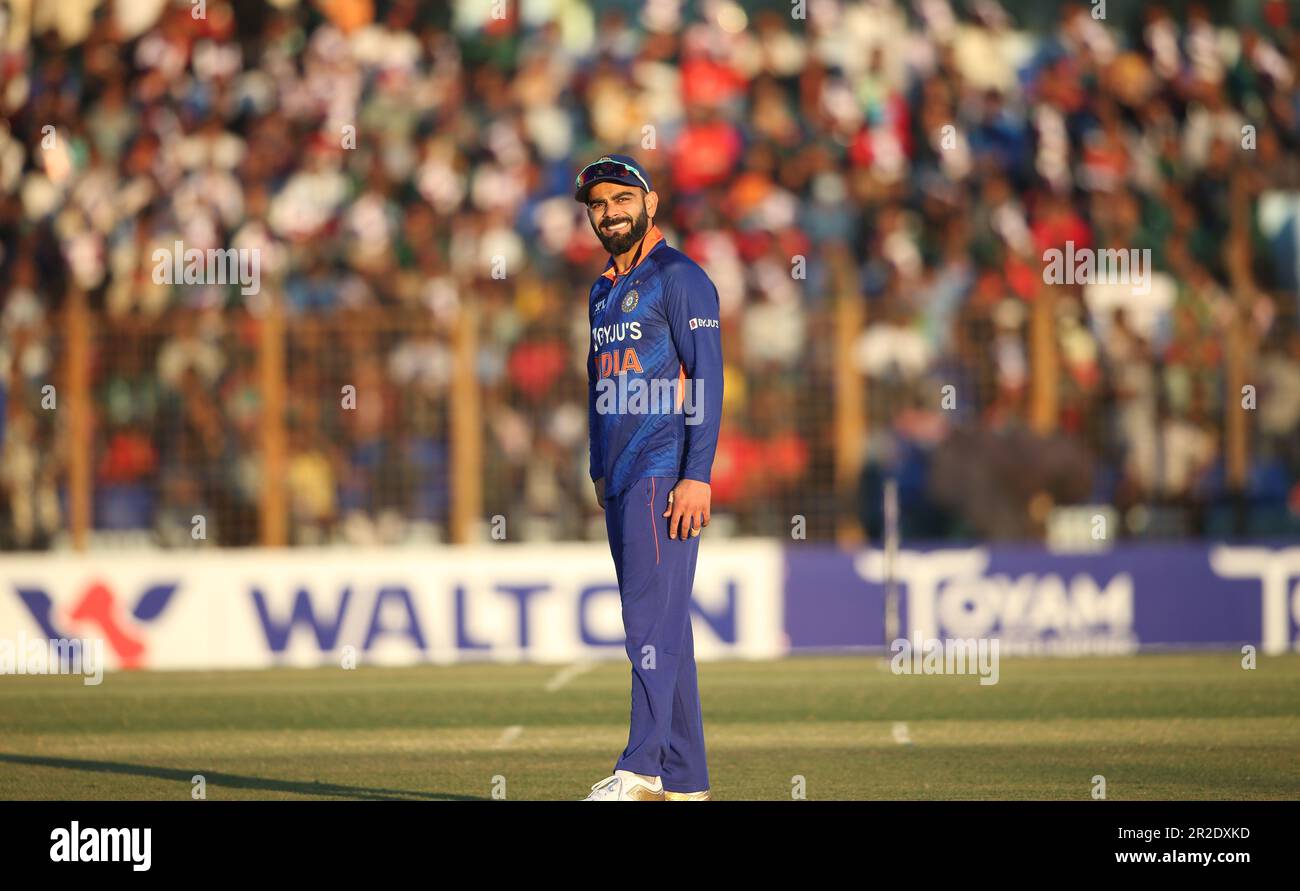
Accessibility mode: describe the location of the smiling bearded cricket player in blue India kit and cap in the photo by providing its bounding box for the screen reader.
[573,155,723,801]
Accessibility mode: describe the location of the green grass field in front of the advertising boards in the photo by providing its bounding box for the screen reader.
[0,653,1300,801]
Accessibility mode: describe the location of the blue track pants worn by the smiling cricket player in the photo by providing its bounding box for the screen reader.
[605,476,709,792]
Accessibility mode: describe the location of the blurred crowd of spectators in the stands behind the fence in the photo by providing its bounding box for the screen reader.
[0,0,1300,548]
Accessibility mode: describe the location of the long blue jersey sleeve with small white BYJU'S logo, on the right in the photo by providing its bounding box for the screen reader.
[664,264,723,483]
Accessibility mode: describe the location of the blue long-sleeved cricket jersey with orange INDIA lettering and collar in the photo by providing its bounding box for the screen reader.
[586,226,723,497]
